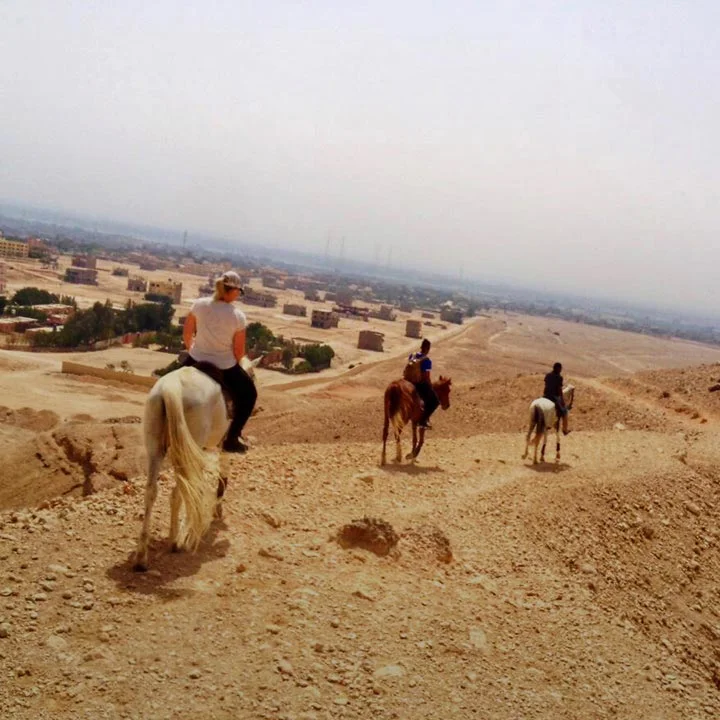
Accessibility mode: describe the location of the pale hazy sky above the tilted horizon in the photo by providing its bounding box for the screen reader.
[0,0,720,312]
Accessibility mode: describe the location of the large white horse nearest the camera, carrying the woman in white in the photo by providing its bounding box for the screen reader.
[134,356,260,572]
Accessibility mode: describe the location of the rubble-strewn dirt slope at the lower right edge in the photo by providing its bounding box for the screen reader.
[527,466,720,686]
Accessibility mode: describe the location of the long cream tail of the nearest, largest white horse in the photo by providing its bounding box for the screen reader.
[161,372,212,550]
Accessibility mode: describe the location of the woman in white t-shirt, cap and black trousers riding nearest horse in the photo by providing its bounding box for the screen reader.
[183,271,257,452]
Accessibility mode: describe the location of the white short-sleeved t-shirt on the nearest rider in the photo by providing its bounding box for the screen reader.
[190,297,247,370]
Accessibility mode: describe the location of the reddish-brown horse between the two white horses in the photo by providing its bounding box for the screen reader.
[380,375,452,465]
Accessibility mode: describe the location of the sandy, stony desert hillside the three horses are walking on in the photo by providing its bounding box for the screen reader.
[0,317,720,720]
